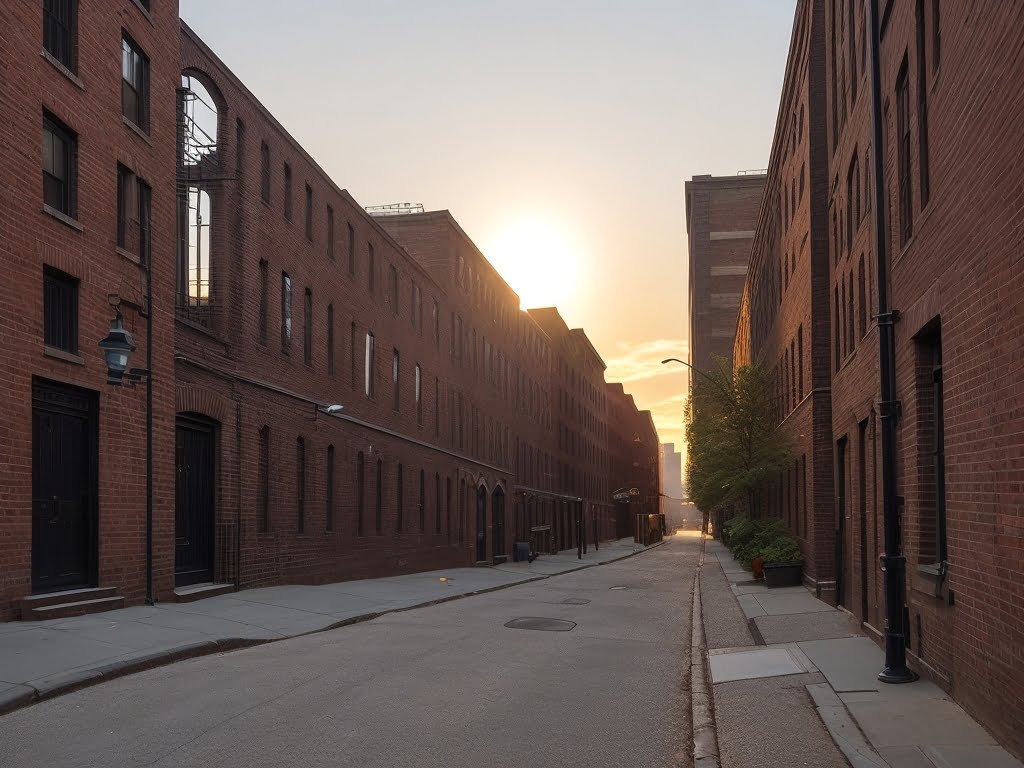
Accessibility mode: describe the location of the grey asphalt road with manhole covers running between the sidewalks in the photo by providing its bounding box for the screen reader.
[0,537,699,768]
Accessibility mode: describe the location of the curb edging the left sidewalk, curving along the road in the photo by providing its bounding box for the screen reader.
[0,541,665,716]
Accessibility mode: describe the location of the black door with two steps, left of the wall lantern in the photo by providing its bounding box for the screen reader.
[32,381,98,592]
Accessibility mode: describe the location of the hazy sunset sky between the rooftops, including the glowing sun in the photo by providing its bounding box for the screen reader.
[180,0,796,475]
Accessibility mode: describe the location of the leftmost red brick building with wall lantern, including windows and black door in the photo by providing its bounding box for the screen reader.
[0,0,180,620]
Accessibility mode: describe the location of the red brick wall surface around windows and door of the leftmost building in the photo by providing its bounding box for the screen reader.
[0,0,179,620]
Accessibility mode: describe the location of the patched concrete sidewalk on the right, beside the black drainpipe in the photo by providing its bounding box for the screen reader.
[700,542,1022,768]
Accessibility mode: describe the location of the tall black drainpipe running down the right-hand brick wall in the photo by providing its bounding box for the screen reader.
[868,0,918,683]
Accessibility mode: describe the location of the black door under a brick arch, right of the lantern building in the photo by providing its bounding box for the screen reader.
[174,416,216,587]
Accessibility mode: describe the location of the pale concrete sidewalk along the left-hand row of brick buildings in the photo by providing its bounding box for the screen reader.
[0,539,649,713]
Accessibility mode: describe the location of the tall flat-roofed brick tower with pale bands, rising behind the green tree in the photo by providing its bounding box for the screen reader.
[686,172,766,378]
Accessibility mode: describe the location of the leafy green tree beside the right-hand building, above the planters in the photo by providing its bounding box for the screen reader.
[686,364,793,528]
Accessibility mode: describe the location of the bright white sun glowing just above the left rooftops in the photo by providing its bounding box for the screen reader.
[484,216,583,309]
